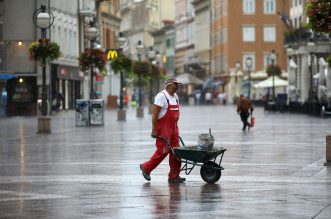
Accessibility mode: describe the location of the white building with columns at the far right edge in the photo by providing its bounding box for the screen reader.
[285,0,331,106]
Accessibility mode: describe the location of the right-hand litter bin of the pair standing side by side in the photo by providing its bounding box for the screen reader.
[90,99,104,126]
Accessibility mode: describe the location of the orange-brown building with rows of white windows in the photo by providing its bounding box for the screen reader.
[211,0,290,76]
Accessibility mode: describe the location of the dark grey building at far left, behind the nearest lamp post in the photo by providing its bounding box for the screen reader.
[0,0,41,115]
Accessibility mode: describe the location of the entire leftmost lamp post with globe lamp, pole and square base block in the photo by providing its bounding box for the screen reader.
[33,5,54,133]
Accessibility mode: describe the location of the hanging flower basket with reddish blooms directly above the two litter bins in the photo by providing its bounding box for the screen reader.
[78,49,107,75]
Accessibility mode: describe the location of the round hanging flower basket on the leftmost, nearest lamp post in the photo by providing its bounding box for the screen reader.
[28,38,62,66]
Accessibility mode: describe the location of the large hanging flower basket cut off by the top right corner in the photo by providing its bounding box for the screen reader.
[306,0,331,33]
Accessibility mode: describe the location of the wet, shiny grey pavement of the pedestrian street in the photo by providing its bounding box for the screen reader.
[0,106,331,219]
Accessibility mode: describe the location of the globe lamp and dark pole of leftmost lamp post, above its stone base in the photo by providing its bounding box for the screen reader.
[33,5,54,116]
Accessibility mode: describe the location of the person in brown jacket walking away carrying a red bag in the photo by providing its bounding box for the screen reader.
[237,94,254,131]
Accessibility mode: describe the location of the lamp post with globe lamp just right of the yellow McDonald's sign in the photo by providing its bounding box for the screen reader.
[117,32,129,121]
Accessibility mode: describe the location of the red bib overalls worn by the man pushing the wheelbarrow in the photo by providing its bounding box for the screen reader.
[142,94,181,179]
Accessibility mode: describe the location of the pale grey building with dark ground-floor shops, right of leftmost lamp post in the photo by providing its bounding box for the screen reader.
[49,0,84,109]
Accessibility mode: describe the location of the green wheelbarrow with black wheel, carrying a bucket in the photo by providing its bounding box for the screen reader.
[158,136,226,183]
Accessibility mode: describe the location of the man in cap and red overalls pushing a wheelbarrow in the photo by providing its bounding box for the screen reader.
[140,79,185,183]
